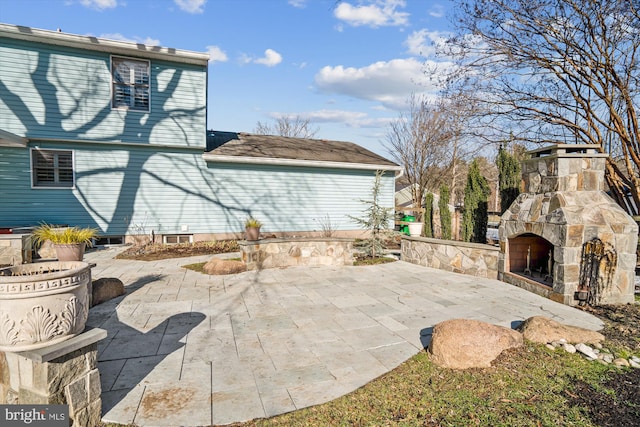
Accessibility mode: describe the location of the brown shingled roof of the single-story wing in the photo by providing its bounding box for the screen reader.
[203,131,401,171]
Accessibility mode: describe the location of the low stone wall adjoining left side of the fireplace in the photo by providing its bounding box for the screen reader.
[402,236,499,279]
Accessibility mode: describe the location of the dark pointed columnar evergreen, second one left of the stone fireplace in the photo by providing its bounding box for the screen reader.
[462,160,491,243]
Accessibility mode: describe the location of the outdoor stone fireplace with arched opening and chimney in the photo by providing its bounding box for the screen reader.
[498,144,638,305]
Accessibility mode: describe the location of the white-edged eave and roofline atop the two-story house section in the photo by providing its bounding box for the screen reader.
[0,24,209,66]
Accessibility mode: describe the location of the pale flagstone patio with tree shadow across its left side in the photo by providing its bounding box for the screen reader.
[85,249,602,426]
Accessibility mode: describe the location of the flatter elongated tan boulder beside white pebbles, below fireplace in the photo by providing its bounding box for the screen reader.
[518,316,604,344]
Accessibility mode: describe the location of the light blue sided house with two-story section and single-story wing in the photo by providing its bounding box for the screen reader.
[0,24,400,243]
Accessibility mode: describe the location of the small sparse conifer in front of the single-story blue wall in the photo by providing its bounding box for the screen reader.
[349,171,393,258]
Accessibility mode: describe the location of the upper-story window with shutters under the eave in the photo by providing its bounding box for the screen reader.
[111,56,150,111]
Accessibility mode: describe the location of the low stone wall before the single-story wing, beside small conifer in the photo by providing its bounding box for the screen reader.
[239,237,353,270]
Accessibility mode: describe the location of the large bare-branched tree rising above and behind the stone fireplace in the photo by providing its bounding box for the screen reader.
[447,0,640,215]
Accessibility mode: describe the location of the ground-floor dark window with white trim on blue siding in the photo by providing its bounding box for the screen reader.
[31,148,74,188]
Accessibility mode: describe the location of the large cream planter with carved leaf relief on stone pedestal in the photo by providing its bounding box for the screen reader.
[0,261,91,352]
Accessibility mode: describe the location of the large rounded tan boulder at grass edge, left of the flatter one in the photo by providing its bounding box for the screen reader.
[429,319,523,369]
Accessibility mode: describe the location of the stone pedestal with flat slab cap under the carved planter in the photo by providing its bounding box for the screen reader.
[0,328,107,427]
